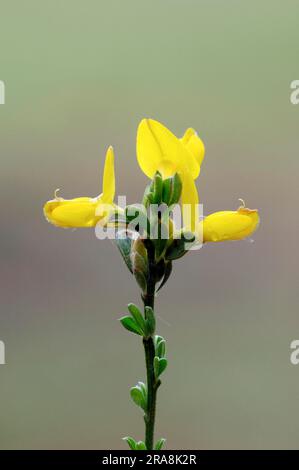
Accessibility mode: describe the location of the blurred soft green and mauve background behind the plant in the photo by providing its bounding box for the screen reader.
[0,0,299,449]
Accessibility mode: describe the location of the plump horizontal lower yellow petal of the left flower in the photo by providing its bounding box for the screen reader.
[44,197,99,228]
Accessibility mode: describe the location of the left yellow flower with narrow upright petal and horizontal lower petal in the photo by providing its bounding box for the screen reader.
[44,147,115,228]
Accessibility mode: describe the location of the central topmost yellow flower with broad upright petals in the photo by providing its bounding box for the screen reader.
[137,119,205,231]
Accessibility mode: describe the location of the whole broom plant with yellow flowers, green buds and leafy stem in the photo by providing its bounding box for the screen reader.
[44,119,259,450]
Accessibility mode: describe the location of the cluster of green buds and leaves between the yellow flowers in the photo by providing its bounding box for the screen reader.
[115,172,195,296]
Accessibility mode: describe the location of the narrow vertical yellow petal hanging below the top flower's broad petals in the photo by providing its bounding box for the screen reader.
[180,172,199,232]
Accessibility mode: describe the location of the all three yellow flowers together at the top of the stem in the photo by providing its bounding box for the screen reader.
[44,119,259,242]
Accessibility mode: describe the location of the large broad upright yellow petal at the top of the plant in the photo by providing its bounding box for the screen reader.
[137,119,198,178]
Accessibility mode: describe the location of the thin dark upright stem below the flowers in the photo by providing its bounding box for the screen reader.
[143,242,160,450]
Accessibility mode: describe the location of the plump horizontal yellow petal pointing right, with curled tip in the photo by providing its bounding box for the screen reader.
[202,207,259,242]
